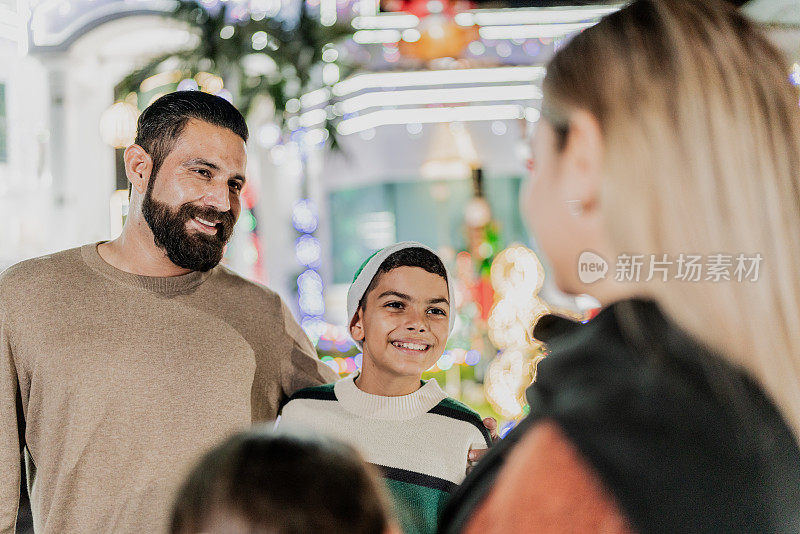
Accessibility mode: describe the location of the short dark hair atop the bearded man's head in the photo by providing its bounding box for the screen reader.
[135,91,249,182]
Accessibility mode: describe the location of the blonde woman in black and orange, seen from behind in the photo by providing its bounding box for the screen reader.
[442,0,800,534]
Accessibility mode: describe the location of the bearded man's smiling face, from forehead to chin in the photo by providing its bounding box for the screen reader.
[142,119,247,271]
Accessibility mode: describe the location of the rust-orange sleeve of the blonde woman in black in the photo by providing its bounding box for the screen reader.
[465,421,632,534]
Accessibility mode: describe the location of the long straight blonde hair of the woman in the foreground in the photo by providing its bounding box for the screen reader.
[544,0,800,436]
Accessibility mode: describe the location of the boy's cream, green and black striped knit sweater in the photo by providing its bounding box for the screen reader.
[279,373,491,534]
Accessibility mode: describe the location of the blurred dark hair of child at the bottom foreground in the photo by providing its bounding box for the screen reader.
[170,429,389,534]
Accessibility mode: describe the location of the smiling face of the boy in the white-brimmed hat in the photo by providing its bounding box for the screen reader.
[350,267,450,386]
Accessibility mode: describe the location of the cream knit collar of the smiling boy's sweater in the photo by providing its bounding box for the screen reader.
[333,372,447,421]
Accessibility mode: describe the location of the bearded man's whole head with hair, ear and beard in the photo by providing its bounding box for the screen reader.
[125,91,248,271]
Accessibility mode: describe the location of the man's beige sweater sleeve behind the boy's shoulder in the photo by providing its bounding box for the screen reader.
[280,300,339,400]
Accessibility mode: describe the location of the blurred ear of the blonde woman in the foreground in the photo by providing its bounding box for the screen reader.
[562,110,603,217]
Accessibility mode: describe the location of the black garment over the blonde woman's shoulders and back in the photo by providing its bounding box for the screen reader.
[440,300,800,533]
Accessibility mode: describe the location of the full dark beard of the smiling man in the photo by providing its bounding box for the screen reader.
[142,180,236,271]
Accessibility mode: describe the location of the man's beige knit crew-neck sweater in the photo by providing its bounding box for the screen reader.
[0,244,337,534]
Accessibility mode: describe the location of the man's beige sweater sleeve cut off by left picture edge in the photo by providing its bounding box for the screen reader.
[0,308,20,534]
